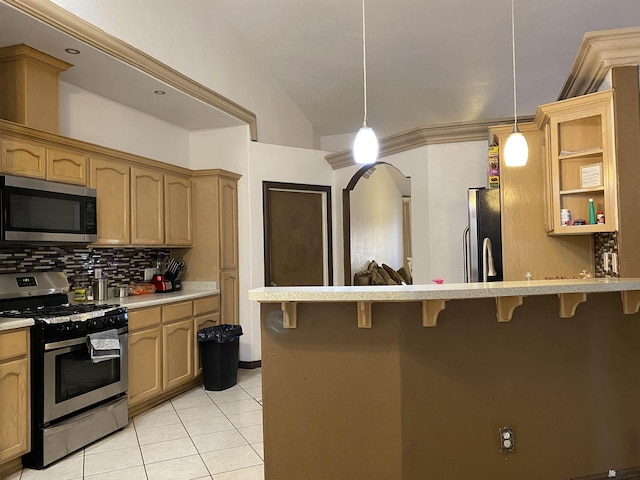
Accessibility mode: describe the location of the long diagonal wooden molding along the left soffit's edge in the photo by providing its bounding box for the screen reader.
[3,0,258,141]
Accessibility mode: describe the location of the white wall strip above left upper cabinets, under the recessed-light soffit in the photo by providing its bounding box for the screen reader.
[60,82,190,167]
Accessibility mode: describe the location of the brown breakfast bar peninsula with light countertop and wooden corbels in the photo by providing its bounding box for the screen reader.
[248,279,640,480]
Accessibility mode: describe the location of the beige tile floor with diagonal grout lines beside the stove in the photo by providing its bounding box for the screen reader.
[8,369,264,480]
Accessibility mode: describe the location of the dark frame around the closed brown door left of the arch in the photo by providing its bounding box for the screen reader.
[262,181,333,287]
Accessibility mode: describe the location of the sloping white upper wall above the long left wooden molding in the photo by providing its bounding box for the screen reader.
[53,0,319,148]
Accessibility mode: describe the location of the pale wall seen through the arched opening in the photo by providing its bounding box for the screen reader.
[349,167,404,278]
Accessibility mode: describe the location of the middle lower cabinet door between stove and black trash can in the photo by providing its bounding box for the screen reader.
[162,318,194,390]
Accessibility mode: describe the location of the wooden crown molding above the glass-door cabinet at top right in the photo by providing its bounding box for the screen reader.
[558,27,640,100]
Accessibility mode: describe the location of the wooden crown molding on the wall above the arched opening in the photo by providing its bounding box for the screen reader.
[324,117,533,170]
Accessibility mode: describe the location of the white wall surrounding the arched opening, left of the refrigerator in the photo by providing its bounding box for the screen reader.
[335,141,488,284]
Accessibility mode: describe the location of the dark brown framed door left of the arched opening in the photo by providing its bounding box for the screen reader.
[264,182,333,284]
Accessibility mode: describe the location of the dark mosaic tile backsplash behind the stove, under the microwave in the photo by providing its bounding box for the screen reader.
[0,245,171,288]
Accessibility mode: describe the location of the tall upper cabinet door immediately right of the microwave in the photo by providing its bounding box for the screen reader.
[89,158,131,245]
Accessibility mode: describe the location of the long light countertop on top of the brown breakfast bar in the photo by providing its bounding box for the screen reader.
[248,278,640,303]
